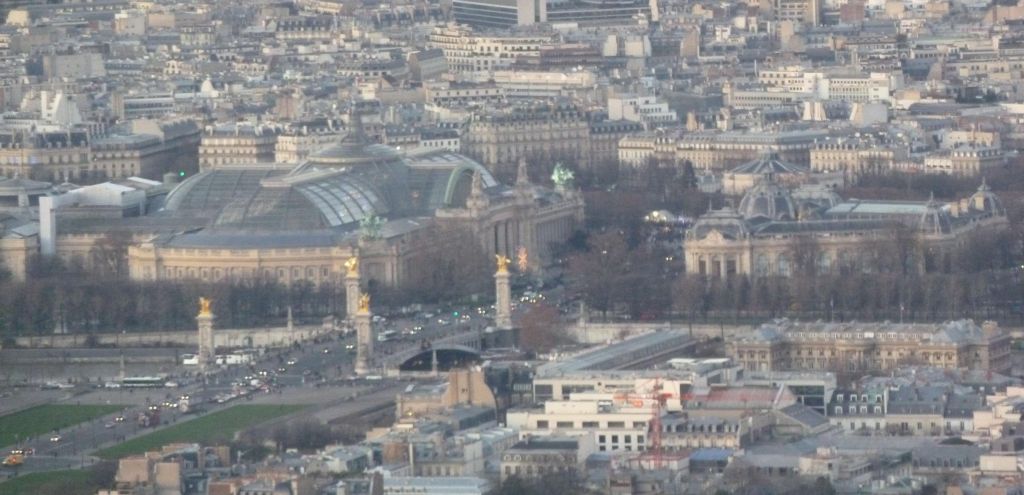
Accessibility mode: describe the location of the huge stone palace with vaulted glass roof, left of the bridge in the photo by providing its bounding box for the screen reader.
[0,118,583,285]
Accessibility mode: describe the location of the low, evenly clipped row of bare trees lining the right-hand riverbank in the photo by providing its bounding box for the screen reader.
[666,272,1024,321]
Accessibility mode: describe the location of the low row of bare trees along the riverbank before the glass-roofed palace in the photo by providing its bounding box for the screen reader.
[0,274,344,336]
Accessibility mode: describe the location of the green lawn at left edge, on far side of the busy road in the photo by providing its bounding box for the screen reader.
[0,404,124,447]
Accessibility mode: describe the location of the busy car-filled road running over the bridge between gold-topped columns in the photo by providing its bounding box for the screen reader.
[0,301,512,478]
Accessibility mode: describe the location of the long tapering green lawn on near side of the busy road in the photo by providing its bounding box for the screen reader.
[96,404,305,459]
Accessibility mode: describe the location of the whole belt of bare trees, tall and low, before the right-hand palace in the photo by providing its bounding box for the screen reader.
[567,229,1024,320]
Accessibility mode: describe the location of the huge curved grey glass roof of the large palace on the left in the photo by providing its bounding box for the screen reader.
[161,147,505,232]
